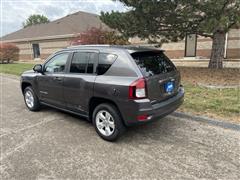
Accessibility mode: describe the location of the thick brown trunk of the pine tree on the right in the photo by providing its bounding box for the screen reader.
[208,31,226,69]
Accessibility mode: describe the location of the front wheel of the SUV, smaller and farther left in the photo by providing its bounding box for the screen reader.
[24,86,40,111]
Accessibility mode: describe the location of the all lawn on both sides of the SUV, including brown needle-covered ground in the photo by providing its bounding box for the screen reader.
[0,63,240,123]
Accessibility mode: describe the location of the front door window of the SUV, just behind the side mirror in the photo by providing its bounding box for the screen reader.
[44,53,69,73]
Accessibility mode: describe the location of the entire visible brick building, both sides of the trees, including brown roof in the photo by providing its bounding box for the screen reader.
[1,11,240,60]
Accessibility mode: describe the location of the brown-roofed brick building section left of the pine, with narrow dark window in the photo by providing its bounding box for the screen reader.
[1,11,110,61]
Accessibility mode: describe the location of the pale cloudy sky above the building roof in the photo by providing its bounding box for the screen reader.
[0,0,126,37]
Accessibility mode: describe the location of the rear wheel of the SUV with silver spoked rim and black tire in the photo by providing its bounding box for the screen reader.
[93,103,126,141]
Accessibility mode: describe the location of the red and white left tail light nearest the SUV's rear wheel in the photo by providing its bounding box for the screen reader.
[128,78,147,99]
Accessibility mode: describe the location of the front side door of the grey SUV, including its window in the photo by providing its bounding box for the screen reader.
[37,52,70,107]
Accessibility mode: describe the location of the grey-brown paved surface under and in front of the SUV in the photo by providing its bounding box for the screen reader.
[0,76,240,180]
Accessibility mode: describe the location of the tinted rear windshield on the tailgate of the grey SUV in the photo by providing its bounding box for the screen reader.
[131,51,176,77]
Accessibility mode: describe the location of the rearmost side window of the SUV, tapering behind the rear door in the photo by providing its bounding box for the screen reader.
[97,53,117,75]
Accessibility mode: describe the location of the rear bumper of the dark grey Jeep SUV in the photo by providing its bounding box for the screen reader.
[122,87,184,126]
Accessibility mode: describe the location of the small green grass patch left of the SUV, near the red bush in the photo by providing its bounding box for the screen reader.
[0,63,34,75]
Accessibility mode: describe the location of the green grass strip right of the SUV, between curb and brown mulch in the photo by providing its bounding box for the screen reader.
[180,83,240,123]
